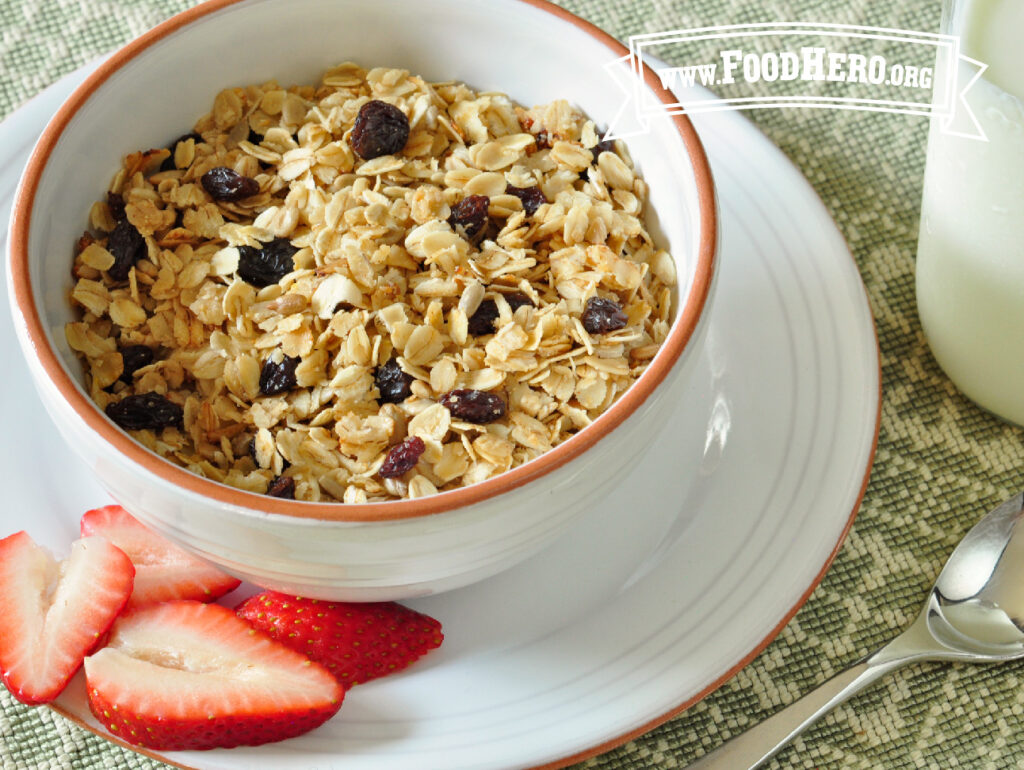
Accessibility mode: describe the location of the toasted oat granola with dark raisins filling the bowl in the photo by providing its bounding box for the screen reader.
[66,62,676,504]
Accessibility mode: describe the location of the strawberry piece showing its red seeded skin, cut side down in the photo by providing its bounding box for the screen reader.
[236,591,444,688]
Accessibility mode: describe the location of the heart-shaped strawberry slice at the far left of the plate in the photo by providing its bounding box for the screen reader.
[0,531,135,703]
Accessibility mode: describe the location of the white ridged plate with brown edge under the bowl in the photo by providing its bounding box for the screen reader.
[0,61,880,770]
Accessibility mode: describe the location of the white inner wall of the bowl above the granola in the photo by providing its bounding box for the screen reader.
[18,0,714,518]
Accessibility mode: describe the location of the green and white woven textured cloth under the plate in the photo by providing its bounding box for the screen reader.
[0,0,1024,770]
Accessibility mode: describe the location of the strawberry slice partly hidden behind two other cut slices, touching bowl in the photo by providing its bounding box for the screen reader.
[81,505,241,607]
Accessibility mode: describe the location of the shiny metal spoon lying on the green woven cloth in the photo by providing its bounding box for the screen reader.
[689,494,1024,770]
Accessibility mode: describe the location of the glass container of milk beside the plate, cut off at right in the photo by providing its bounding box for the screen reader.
[916,0,1024,425]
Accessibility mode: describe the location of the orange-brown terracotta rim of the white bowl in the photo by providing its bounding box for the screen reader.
[10,0,718,521]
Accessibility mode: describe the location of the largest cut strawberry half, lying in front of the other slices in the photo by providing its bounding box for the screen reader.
[85,601,345,751]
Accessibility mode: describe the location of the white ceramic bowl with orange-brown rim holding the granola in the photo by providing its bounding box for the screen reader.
[8,0,717,601]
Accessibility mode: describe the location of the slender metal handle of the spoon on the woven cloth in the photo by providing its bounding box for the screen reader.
[687,627,926,770]
